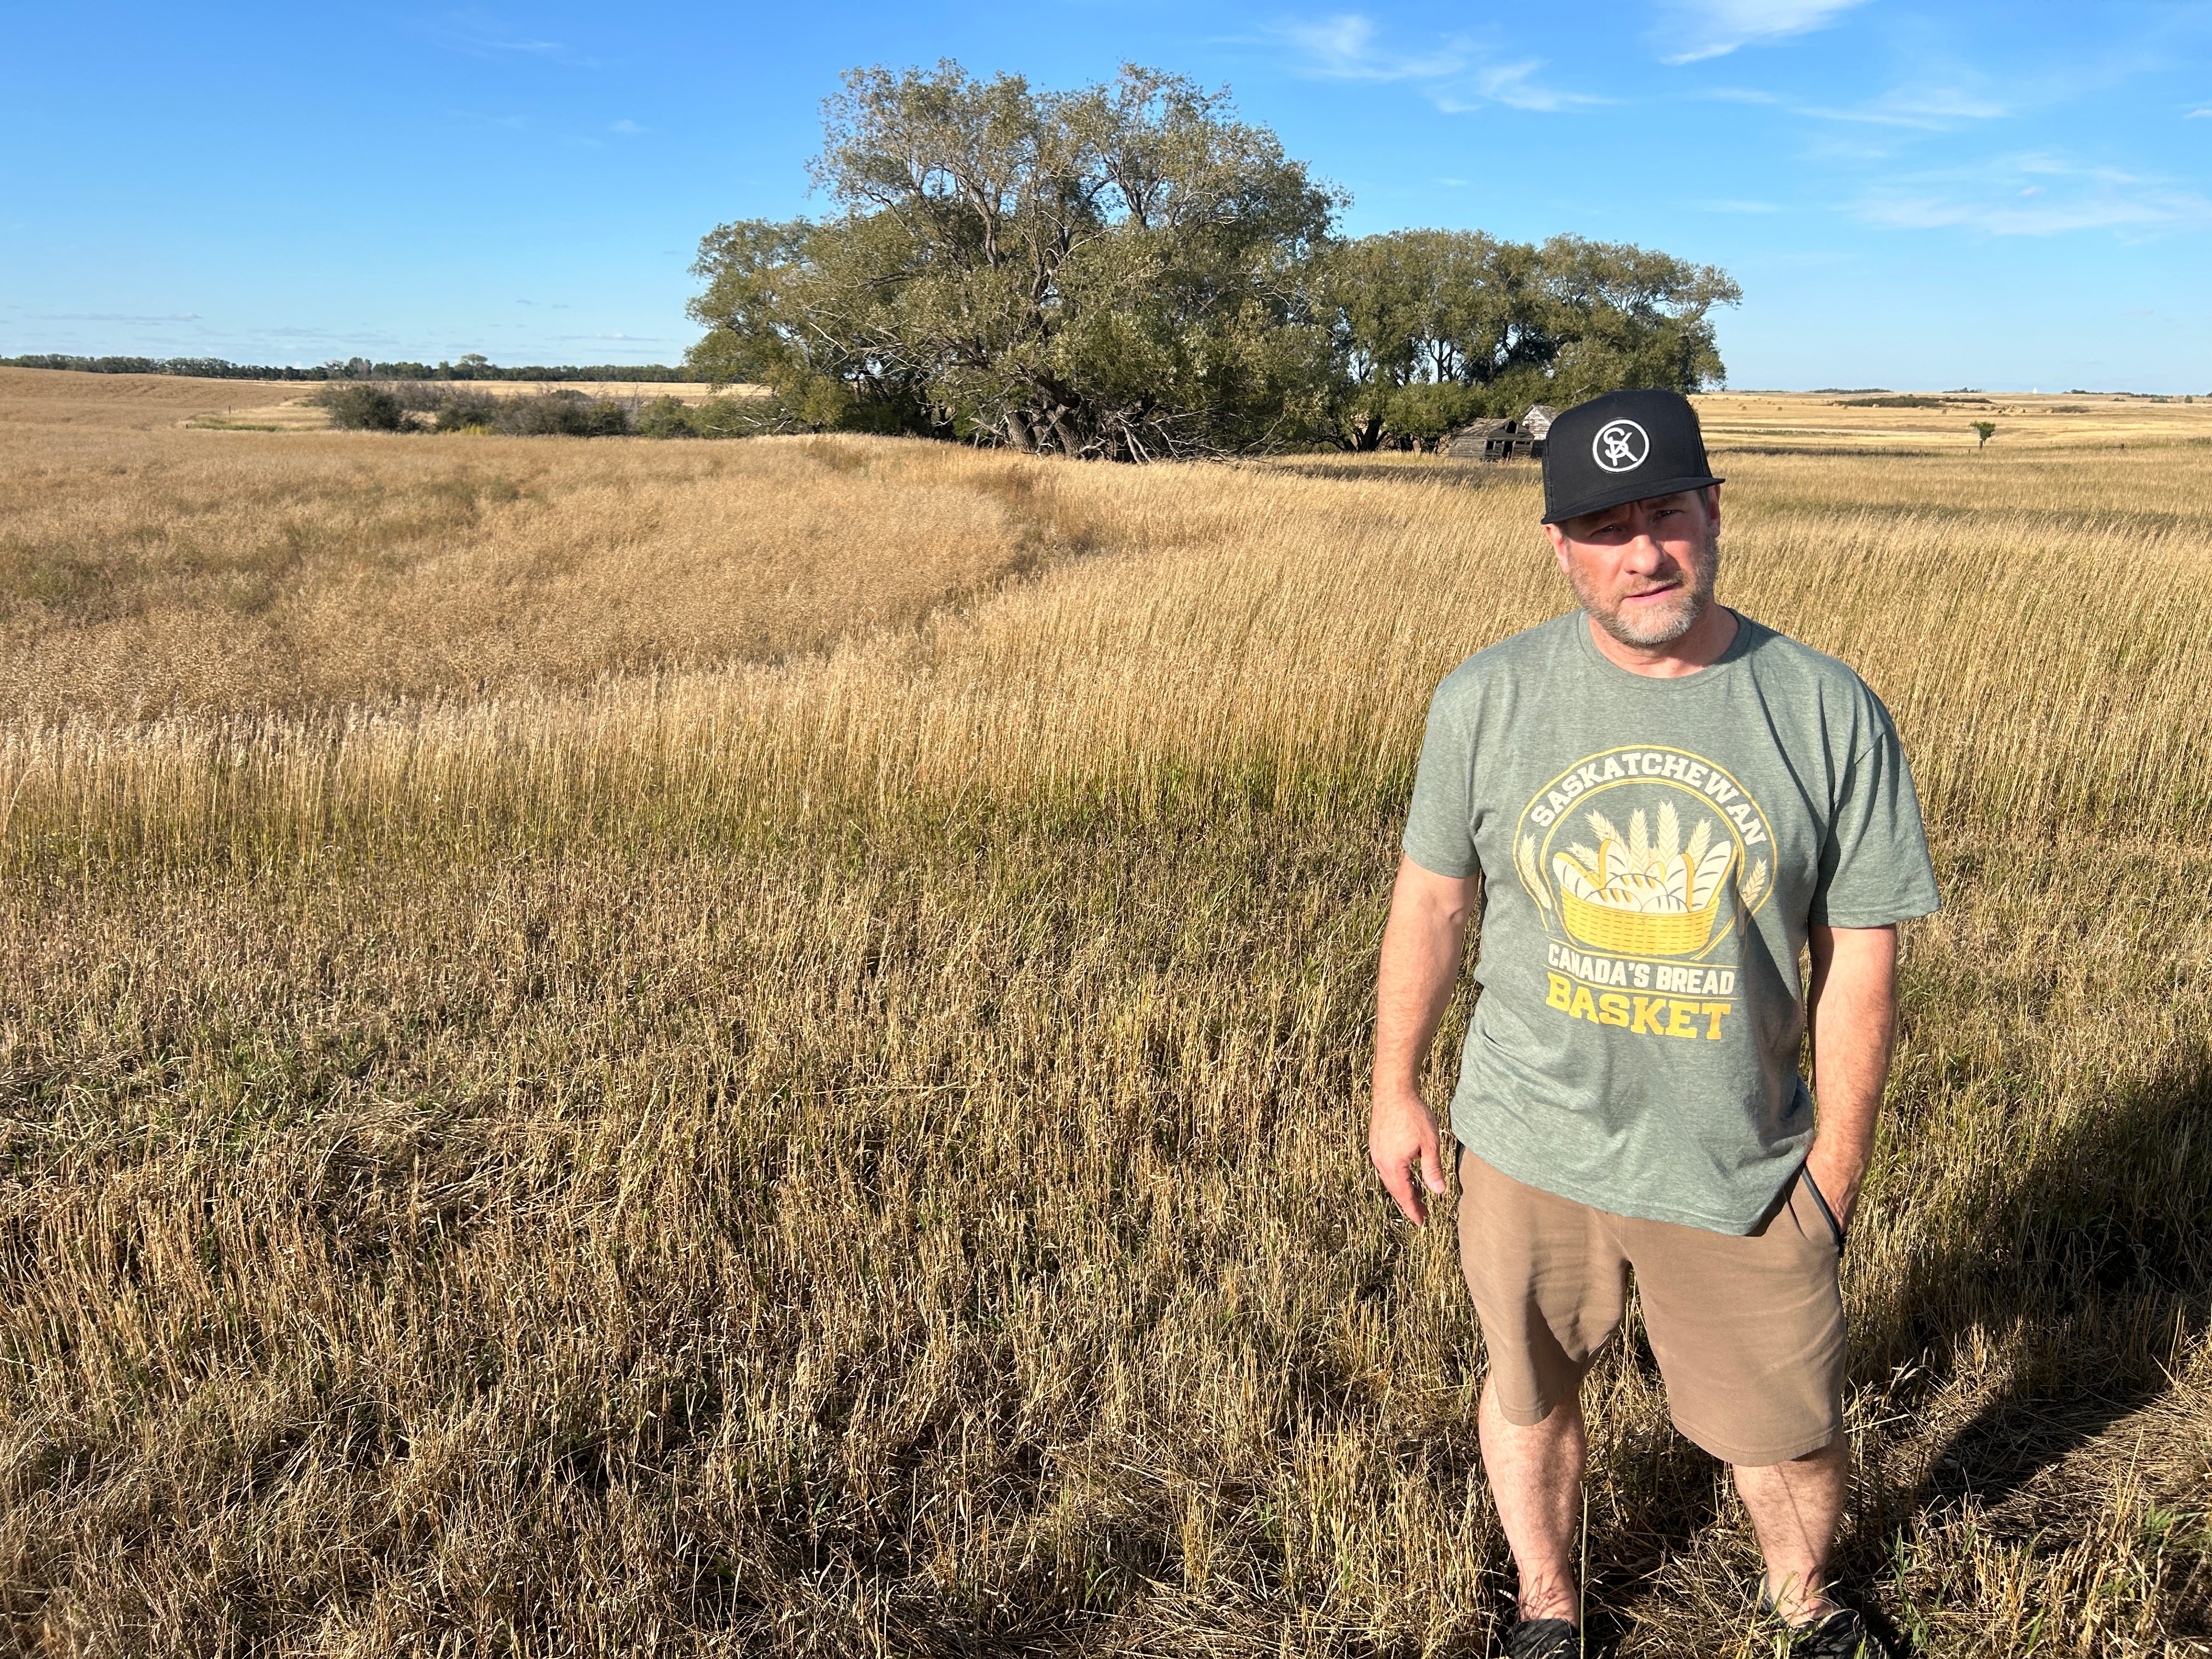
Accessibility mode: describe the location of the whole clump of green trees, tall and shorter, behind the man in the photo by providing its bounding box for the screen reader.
[688,62,1741,460]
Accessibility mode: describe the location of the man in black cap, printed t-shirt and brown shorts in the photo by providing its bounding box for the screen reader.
[1369,392,1938,1659]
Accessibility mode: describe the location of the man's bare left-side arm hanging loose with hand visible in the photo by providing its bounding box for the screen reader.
[1367,858,1480,1221]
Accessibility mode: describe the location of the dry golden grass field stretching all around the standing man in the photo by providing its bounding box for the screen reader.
[0,376,2212,1659]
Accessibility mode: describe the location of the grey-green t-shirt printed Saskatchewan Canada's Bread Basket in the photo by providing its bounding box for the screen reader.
[1404,611,1938,1234]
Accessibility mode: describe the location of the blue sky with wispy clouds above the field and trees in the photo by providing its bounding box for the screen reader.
[0,0,2212,392]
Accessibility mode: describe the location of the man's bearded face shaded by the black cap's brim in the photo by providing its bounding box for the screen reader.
[1544,484,1721,646]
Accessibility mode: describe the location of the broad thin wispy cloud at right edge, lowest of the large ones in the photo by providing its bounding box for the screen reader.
[1854,153,2212,236]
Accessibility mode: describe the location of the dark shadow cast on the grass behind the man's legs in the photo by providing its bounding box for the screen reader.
[1588,1044,2212,1655]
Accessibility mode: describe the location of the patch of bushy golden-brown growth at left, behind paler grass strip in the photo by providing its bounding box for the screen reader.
[0,380,1070,721]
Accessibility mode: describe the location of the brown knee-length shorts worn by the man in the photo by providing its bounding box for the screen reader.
[1460,1150,1843,1466]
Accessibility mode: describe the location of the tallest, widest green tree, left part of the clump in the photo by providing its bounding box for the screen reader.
[690,64,1334,458]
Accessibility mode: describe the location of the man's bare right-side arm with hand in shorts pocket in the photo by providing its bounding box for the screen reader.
[1805,927,1898,1223]
